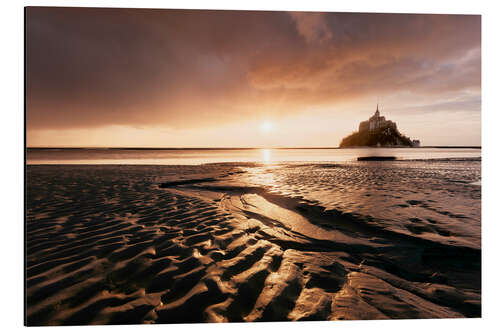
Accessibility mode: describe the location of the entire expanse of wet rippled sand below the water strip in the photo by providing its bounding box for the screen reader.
[26,160,481,325]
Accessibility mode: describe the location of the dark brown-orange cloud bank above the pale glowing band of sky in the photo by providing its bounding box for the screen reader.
[26,8,481,129]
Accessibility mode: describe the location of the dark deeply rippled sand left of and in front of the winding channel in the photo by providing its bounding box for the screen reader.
[26,166,480,325]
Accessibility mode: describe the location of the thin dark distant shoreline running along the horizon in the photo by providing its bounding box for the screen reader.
[26,146,482,150]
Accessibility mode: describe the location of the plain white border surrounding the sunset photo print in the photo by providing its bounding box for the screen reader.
[0,0,500,333]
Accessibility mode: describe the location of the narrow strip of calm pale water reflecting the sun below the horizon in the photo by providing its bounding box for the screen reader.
[27,148,481,165]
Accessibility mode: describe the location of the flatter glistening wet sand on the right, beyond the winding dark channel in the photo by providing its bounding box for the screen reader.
[241,159,481,249]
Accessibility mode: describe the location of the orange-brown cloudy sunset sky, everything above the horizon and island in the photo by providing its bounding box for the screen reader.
[26,7,481,147]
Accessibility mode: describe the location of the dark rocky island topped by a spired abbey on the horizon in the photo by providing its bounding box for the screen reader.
[339,104,420,148]
